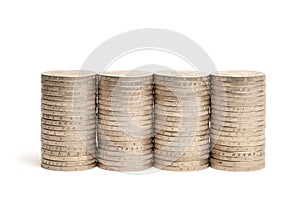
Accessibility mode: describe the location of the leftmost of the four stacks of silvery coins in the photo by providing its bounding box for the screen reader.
[41,71,97,171]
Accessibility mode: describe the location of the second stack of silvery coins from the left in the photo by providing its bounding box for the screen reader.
[98,70,153,171]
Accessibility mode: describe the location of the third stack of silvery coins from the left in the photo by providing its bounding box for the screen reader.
[154,71,210,171]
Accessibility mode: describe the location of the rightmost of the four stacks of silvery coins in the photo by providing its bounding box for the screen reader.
[210,71,266,171]
